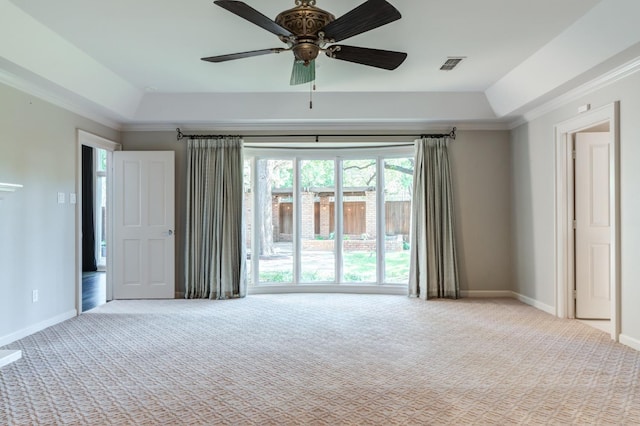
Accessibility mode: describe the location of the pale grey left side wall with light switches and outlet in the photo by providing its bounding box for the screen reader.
[0,84,119,341]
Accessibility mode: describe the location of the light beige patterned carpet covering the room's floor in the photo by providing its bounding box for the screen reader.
[0,294,640,425]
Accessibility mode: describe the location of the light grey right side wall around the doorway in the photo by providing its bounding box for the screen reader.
[511,73,640,344]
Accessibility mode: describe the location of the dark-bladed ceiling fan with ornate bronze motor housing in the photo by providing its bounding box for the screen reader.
[202,0,407,85]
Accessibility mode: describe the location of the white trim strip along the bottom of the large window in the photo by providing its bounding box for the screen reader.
[247,284,409,296]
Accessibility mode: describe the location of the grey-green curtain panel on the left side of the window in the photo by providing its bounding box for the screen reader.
[185,138,247,299]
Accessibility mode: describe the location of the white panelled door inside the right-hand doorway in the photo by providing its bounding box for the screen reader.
[575,132,612,319]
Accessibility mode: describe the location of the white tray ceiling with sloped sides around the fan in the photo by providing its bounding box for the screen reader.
[0,0,640,128]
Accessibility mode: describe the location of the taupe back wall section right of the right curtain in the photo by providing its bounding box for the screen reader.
[450,131,512,295]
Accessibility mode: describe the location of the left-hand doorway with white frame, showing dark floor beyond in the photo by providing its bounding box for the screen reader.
[76,130,121,314]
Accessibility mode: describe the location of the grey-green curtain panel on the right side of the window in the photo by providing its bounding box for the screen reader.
[409,138,460,299]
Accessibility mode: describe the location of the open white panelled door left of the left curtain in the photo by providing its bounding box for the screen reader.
[113,151,175,299]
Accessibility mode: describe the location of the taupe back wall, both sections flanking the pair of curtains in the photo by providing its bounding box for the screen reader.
[122,131,511,292]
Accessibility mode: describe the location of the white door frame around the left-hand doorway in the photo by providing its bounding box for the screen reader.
[75,129,122,315]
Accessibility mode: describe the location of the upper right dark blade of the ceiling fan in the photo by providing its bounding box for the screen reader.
[322,0,402,42]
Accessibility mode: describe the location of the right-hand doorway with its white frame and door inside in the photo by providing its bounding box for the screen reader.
[555,103,620,341]
